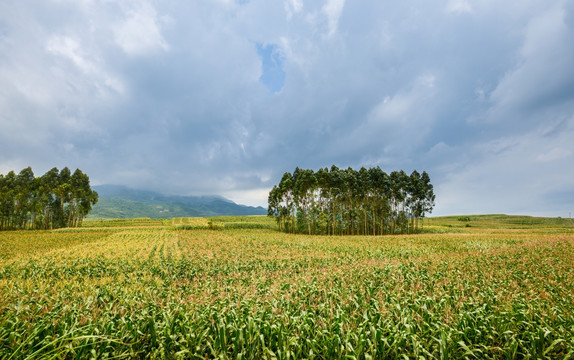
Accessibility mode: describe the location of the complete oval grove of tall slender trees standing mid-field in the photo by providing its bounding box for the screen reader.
[268,165,435,235]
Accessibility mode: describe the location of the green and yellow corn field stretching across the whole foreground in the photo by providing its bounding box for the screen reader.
[0,216,574,359]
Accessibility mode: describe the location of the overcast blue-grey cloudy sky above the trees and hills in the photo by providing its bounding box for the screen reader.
[0,0,574,217]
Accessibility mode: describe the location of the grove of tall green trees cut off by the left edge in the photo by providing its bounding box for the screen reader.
[0,167,98,230]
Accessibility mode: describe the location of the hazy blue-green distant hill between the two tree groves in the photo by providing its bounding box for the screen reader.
[88,185,267,219]
